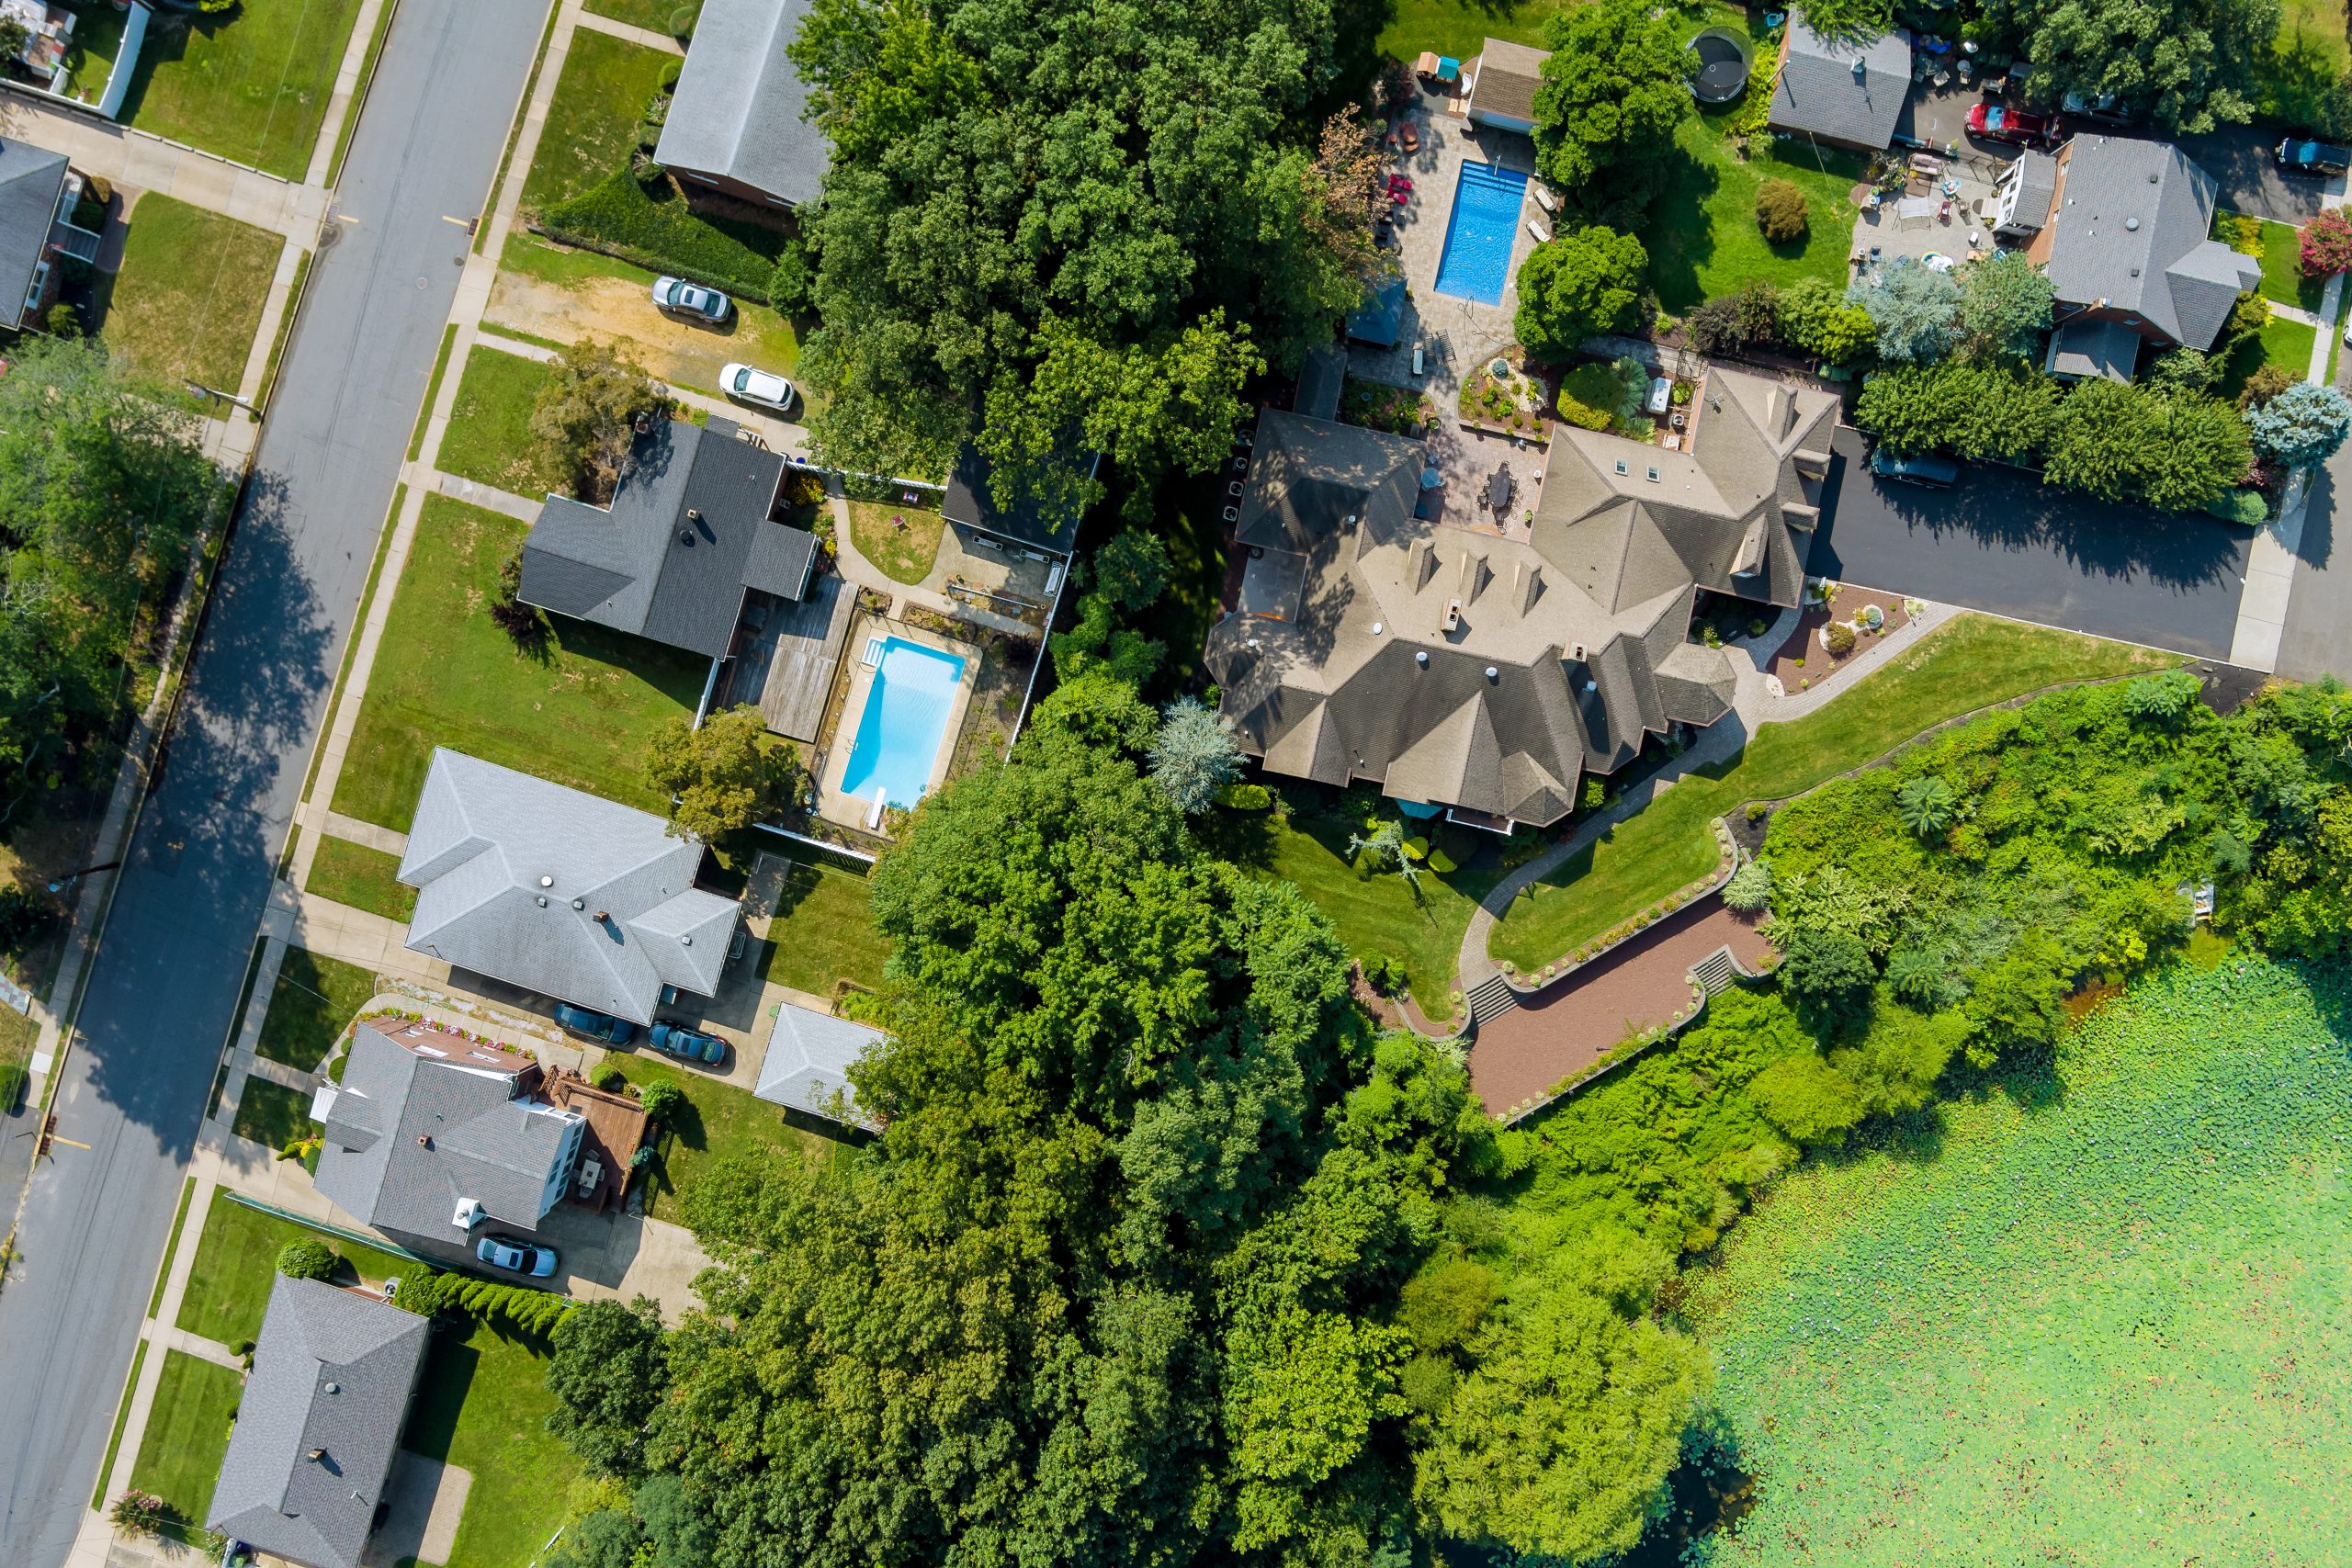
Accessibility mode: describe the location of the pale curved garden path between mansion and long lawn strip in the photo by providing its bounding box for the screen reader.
[1456,604,1964,991]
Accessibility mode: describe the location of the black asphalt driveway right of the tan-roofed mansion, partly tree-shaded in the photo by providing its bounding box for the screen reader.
[1811,425,2253,660]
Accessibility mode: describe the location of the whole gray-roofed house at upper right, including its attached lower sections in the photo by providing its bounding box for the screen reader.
[1996,136,2263,381]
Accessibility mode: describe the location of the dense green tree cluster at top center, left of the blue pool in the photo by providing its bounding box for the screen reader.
[793,0,1376,510]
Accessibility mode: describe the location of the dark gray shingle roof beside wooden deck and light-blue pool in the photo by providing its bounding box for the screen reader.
[520,419,816,659]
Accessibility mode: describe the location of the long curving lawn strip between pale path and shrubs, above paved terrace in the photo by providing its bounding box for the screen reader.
[1488,616,2178,968]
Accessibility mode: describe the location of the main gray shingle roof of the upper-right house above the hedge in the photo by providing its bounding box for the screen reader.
[2044,136,2263,348]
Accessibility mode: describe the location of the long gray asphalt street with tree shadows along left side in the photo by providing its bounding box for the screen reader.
[0,0,546,1568]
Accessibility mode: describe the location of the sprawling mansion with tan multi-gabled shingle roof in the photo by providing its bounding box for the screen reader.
[1204,369,1837,829]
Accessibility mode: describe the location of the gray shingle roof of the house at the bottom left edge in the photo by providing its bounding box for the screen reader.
[205,1274,430,1568]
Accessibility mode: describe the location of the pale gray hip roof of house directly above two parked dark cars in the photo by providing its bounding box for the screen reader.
[400,748,739,1022]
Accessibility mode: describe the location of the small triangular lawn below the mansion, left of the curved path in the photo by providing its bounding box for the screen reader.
[1200,795,1500,1022]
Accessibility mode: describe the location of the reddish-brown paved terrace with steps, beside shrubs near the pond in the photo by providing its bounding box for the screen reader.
[1470,896,1771,1112]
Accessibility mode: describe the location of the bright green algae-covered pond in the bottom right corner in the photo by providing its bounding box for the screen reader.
[1684,957,2352,1568]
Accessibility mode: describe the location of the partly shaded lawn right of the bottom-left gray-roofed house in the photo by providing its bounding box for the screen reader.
[400,1319,581,1568]
